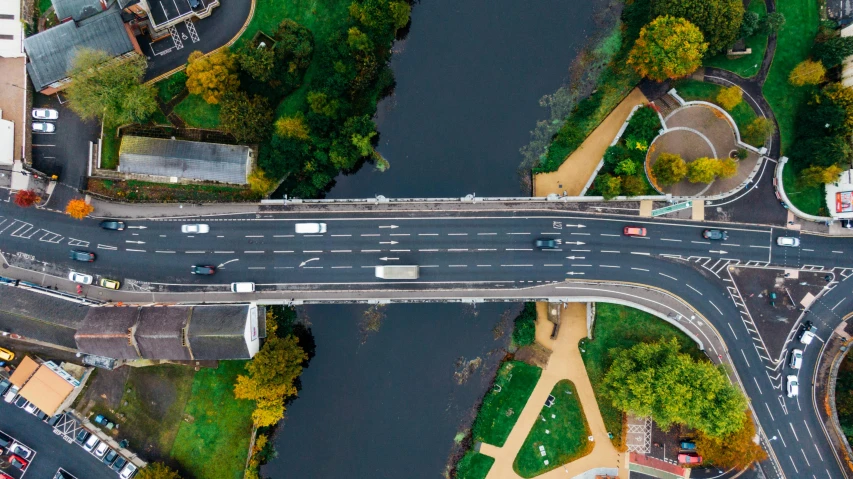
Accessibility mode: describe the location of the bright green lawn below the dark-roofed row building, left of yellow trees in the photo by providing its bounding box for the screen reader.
[171,361,255,479]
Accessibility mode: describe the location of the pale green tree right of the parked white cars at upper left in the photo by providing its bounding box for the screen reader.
[65,48,157,127]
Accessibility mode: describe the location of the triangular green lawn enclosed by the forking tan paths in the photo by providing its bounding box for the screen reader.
[512,379,593,477]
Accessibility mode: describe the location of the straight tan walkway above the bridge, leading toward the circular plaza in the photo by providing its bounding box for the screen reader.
[533,88,649,196]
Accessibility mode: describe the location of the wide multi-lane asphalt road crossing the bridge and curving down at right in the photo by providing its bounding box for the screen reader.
[0,204,853,478]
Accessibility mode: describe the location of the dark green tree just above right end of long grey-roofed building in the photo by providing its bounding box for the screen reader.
[219,91,273,143]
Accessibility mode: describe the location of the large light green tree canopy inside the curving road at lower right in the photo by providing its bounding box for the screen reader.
[602,339,747,437]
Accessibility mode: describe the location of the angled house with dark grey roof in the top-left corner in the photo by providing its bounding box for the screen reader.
[24,2,142,95]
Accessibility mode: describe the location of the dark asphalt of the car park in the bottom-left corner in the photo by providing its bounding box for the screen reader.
[0,401,118,479]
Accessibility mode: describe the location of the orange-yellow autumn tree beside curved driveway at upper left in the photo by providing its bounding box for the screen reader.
[187,51,240,104]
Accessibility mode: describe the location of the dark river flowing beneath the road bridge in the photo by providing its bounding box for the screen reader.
[262,0,594,479]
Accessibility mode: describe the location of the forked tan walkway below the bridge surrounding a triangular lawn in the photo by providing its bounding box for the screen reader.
[480,303,628,479]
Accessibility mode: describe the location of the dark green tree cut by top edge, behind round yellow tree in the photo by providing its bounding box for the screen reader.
[652,0,744,55]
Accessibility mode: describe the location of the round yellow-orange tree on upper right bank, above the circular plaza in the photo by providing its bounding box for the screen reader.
[628,15,708,81]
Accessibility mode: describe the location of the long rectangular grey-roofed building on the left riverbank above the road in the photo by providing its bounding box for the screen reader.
[118,135,254,185]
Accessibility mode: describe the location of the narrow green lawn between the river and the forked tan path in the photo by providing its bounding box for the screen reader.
[471,361,542,447]
